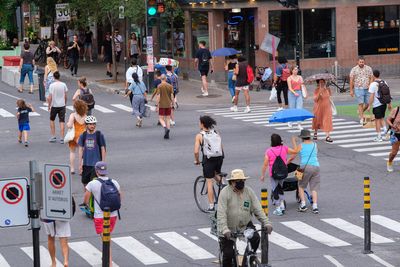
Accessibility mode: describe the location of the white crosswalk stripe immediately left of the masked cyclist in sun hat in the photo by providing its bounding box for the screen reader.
[155,232,215,260]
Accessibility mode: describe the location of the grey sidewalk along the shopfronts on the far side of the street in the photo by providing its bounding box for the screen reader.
[59,62,400,106]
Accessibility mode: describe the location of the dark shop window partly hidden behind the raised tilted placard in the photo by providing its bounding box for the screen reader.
[268,10,296,59]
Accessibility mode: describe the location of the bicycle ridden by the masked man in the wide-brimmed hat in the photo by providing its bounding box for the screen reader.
[219,228,263,267]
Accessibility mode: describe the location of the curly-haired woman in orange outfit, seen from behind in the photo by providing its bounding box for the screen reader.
[65,99,87,174]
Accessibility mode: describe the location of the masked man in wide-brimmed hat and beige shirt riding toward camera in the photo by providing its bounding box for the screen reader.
[217,169,272,267]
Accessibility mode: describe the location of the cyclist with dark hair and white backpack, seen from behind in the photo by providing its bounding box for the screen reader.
[194,116,224,212]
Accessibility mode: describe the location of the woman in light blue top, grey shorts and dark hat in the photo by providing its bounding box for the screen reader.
[293,130,321,214]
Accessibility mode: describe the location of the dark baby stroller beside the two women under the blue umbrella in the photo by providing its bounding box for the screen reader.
[271,163,313,208]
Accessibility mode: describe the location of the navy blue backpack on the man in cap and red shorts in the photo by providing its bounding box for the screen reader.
[95,178,121,211]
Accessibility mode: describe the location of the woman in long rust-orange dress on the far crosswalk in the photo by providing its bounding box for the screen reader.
[312,79,333,143]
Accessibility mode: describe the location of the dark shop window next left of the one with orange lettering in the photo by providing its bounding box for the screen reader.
[303,9,336,58]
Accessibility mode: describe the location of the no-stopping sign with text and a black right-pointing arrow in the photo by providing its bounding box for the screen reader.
[41,164,72,221]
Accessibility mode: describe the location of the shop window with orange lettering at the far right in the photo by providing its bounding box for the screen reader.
[357,6,400,55]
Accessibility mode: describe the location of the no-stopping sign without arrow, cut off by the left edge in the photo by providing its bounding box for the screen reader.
[0,177,29,228]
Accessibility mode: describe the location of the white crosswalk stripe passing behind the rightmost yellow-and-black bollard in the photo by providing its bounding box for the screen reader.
[321,218,394,244]
